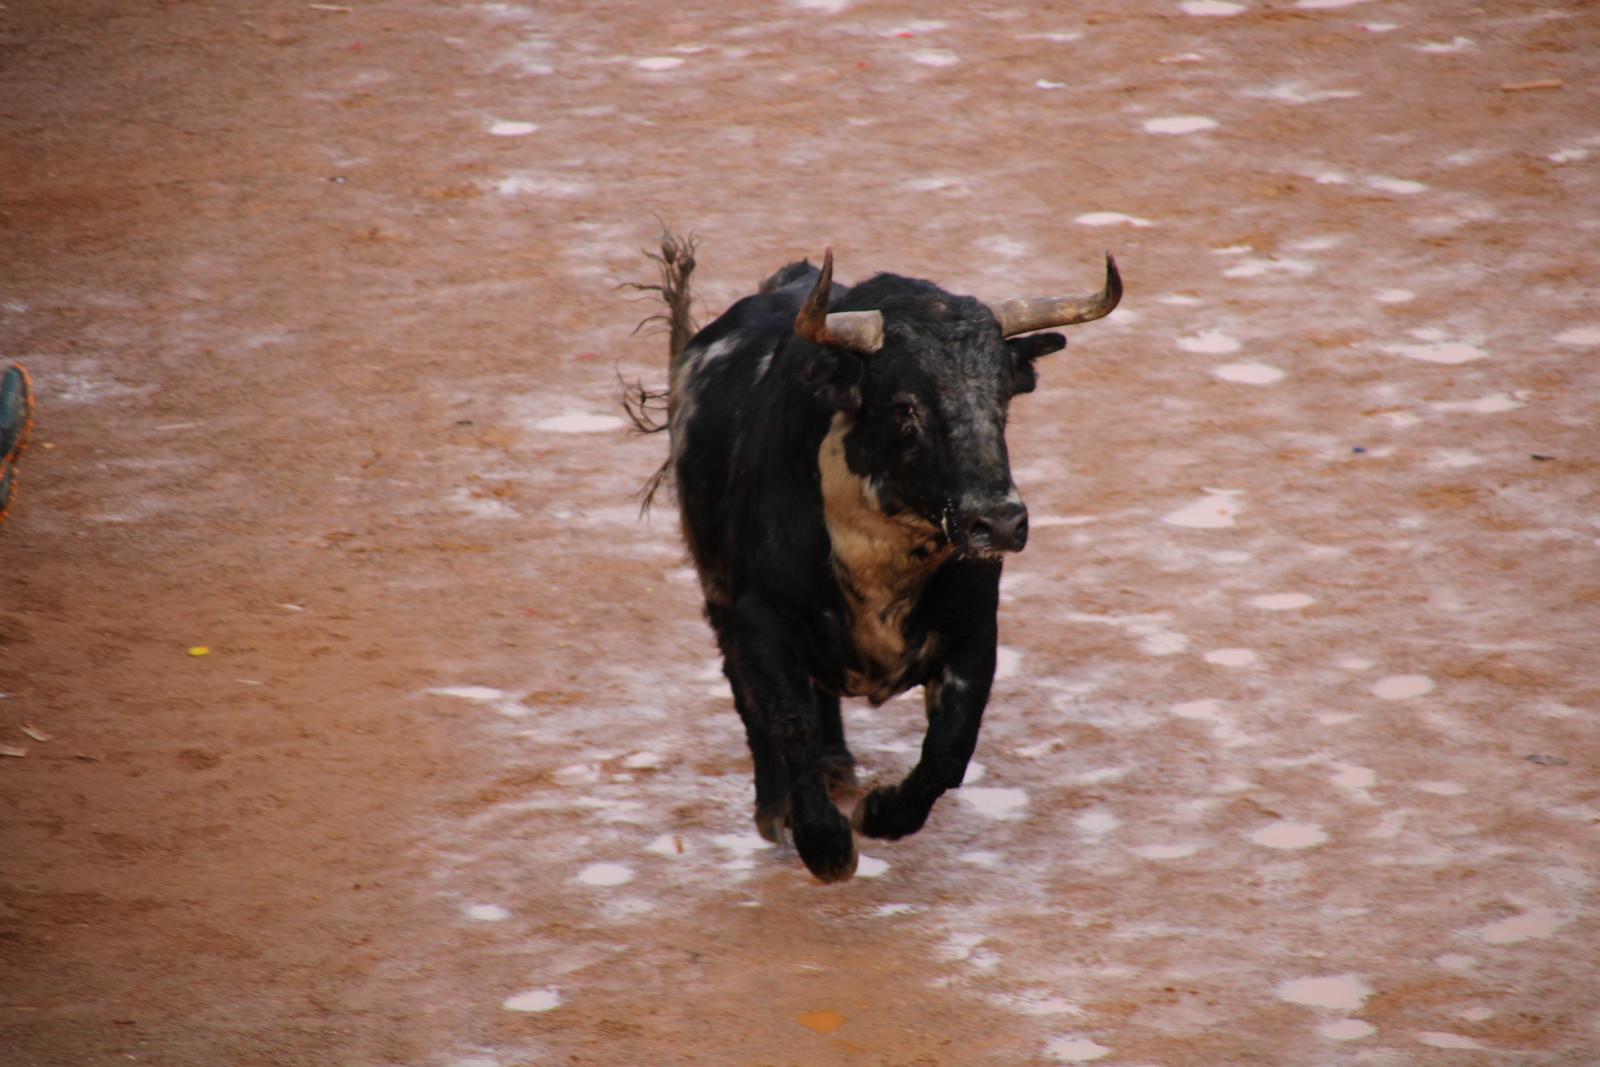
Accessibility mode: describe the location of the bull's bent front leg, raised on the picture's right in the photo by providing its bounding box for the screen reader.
[850,627,995,840]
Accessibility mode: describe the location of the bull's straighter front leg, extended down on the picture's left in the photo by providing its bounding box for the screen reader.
[728,595,856,881]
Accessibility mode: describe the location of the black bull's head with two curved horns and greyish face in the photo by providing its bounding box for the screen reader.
[795,250,1122,557]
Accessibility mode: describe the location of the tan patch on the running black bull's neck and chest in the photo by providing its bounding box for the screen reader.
[818,414,950,702]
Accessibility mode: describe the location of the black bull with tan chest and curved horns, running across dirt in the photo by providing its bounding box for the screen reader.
[617,235,1122,881]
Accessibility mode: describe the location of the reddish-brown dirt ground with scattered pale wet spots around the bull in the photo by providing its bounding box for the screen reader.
[0,0,1600,1067]
